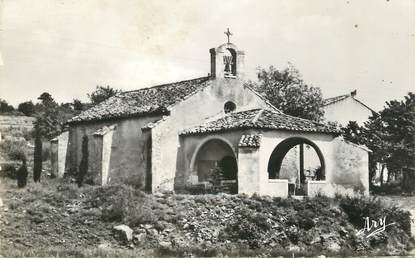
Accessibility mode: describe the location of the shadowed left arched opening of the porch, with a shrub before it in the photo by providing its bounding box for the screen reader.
[194,139,238,194]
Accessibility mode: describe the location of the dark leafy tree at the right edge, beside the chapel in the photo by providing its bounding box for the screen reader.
[343,93,415,190]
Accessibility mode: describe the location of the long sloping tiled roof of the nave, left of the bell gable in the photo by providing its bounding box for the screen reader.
[68,77,208,123]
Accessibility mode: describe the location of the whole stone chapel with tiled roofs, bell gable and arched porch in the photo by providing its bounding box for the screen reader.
[52,34,370,197]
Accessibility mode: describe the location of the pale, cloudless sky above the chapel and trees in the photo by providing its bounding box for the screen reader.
[0,0,415,110]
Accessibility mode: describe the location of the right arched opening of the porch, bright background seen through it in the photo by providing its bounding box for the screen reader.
[268,137,325,193]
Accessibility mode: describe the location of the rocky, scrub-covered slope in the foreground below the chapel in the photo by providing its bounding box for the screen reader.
[0,176,411,257]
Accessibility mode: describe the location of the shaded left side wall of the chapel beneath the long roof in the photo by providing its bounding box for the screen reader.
[67,116,160,189]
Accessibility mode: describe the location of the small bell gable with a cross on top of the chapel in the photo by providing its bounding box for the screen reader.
[210,28,245,79]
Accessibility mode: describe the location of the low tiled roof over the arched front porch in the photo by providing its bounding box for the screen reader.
[181,109,340,134]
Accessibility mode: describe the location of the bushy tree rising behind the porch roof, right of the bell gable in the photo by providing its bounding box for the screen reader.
[248,64,324,121]
